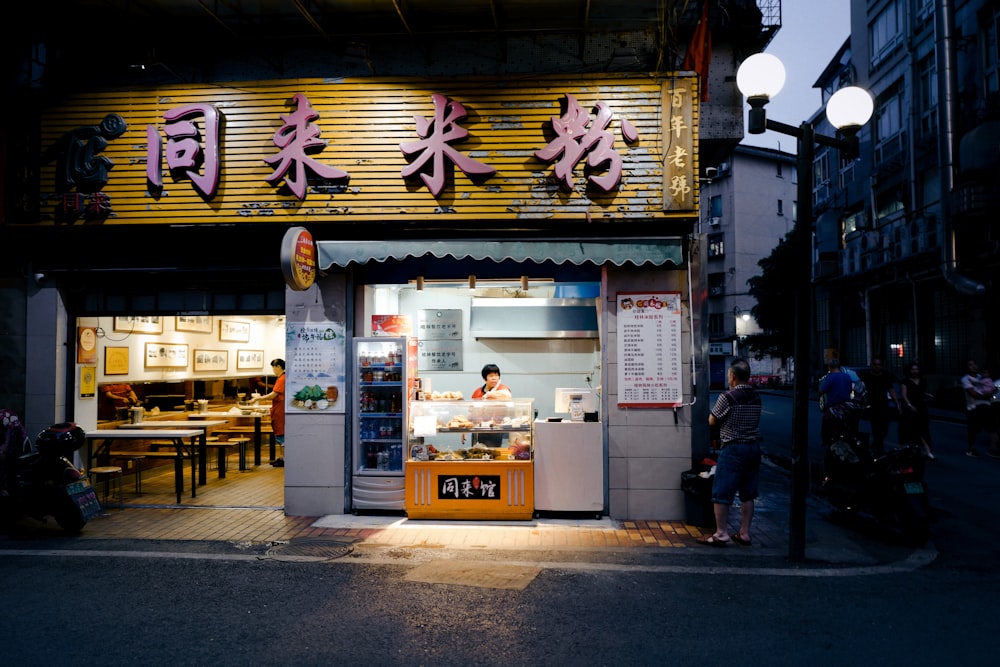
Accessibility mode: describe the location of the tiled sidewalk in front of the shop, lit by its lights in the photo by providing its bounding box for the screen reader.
[0,462,933,567]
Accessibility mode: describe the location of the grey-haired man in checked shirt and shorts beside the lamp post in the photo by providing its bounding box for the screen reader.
[698,359,761,547]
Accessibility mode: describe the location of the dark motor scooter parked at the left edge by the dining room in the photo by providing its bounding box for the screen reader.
[0,410,101,535]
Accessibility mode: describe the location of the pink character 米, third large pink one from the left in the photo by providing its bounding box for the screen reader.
[399,94,496,197]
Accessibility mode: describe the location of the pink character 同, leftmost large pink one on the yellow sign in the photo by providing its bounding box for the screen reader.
[146,104,220,197]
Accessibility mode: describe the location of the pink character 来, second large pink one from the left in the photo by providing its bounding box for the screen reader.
[264,93,350,199]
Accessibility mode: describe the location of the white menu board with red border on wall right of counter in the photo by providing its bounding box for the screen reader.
[615,292,682,408]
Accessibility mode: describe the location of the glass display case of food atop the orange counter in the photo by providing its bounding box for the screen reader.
[408,398,534,461]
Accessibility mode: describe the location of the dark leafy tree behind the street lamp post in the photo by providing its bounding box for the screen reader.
[745,225,808,359]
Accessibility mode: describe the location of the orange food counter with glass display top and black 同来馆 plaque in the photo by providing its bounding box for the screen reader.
[406,398,534,520]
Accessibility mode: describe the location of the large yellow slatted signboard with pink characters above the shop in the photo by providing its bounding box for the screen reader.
[31,72,698,227]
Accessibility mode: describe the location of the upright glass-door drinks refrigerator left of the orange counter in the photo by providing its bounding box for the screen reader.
[351,337,407,511]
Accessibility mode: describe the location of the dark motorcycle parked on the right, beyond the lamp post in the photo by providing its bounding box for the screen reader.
[822,437,930,547]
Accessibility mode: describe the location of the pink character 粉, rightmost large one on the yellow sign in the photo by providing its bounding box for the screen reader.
[535,94,622,192]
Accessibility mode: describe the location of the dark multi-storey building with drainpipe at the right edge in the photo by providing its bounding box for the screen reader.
[812,0,1000,407]
